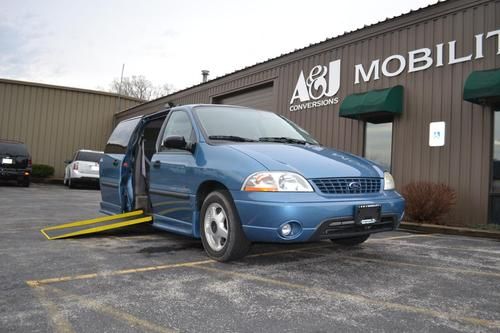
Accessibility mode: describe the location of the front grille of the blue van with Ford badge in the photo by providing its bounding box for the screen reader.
[312,177,382,194]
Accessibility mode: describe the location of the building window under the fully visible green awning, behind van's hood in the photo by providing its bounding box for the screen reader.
[364,122,392,171]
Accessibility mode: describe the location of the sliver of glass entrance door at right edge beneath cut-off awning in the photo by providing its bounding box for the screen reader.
[489,111,500,224]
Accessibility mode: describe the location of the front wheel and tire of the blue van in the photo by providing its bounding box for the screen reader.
[200,191,251,262]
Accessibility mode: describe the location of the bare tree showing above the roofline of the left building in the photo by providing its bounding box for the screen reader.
[110,75,172,101]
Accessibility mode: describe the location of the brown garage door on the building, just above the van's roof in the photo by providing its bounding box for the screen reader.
[214,85,274,111]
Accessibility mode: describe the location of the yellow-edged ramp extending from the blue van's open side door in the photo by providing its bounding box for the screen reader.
[40,210,153,240]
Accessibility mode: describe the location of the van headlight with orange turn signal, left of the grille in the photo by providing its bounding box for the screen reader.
[241,171,314,192]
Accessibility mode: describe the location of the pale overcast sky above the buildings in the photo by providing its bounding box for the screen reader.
[0,0,436,90]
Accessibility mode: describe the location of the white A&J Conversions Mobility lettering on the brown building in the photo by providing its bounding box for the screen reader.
[289,30,500,112]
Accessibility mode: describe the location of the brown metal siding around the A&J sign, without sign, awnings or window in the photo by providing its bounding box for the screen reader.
[118,0,500,225]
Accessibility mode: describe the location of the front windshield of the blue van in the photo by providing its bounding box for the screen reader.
[195,106,318,145]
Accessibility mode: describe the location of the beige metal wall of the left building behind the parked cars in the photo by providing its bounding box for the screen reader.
[0,80,139,177]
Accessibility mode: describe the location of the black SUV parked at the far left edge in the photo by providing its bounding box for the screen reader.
[0,140,31,187]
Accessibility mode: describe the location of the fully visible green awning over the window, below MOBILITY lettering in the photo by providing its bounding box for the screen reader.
[340,86,403,123]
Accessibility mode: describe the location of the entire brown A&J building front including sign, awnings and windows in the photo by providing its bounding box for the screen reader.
[116,0,500,225]
